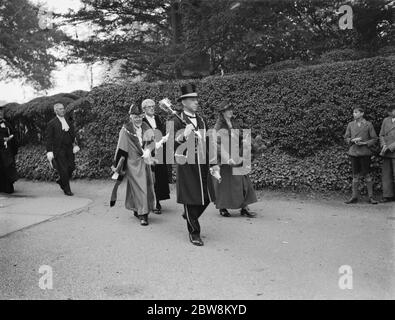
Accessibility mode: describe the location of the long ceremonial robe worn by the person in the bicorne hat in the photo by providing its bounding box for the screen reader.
[116,123,156,215]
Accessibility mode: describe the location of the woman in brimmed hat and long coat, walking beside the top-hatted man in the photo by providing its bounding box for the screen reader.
[214,101,257,217]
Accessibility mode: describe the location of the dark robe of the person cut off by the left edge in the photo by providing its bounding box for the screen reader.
[0,121,18,193]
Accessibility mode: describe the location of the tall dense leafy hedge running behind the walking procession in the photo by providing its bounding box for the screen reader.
[7,56,395,191]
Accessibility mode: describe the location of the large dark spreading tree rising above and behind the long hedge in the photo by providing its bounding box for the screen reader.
[66,0,394,80]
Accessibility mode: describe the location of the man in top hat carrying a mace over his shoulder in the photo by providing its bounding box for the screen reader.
[173,84,214,246]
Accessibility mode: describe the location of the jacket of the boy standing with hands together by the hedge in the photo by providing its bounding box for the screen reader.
[344,119,378,157]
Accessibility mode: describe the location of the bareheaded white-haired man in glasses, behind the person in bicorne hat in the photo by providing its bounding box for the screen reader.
[141,99,170,214]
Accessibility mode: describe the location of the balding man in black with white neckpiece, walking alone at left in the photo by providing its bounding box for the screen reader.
[46,103,79,196]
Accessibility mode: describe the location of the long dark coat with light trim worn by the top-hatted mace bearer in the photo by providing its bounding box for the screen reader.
[173,112,215,206]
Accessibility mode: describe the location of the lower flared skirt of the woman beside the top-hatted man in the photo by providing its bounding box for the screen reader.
[213,165,258,209]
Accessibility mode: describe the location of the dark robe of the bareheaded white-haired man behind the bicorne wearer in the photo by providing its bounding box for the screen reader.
[143,115,170,201]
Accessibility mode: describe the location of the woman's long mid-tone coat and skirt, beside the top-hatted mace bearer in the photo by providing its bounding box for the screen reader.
[214,117,258,209]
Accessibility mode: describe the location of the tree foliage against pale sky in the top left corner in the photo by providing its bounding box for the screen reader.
[0,0,63,89]
